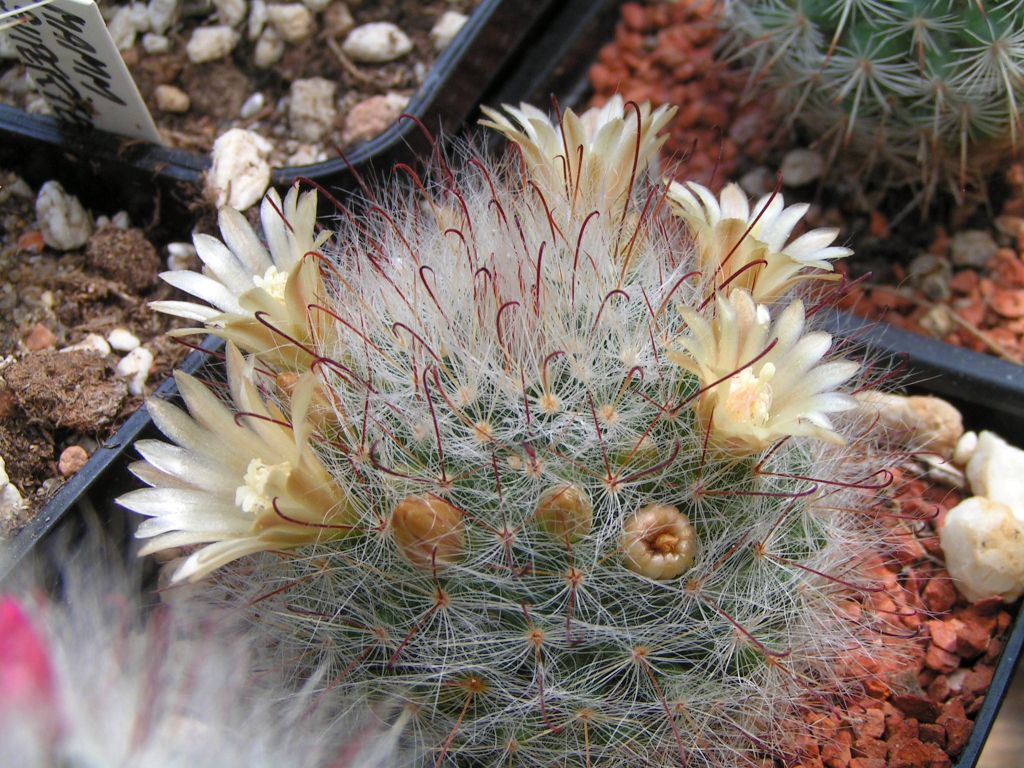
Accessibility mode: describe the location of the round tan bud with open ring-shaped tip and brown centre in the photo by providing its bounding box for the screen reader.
[622,504,697,580]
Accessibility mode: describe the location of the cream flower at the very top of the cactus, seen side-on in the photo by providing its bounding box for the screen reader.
[480,95,676,221]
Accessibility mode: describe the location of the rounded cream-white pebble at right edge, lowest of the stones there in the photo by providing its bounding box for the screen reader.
[939,496,1024,602]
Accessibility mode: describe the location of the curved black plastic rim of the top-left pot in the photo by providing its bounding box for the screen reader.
[0,0,559,221]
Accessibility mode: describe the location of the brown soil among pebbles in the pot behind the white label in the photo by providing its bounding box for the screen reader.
[0,0,479,166]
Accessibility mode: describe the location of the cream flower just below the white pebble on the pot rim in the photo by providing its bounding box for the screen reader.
[151,186,332,370]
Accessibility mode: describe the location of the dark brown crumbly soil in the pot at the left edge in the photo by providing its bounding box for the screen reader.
[0,171,188,536]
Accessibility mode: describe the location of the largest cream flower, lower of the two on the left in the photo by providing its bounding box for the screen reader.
[118,342,354,582]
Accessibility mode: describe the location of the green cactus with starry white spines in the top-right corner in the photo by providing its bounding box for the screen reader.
[725,0,1024,201]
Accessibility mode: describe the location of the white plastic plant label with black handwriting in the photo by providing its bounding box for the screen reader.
[0,0,161,144]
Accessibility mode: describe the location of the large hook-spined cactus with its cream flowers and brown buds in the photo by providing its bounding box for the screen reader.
[121,99,905,766]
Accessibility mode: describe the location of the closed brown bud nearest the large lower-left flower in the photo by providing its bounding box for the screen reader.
[391,495,466,570]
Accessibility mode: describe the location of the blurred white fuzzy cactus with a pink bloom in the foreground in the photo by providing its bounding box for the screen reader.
[0,544,409,768]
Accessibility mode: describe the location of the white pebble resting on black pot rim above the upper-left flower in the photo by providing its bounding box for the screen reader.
[206,128,273,211]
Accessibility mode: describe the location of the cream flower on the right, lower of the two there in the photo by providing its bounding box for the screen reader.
[668,290,859,456]
